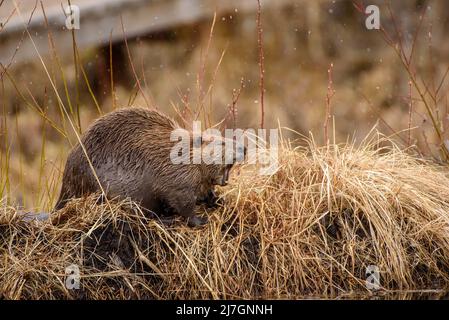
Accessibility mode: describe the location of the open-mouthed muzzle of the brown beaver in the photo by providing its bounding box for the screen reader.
[202,135,247,186]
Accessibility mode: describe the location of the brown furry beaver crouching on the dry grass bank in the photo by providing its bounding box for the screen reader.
[55,107,246,226]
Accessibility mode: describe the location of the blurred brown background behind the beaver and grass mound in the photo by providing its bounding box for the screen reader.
[0,0,449,209]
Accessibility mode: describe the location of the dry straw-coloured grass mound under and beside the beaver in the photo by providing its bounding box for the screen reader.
[0,137,449,299]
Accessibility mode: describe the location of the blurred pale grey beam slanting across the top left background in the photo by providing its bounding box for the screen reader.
[0,0,293,64]
